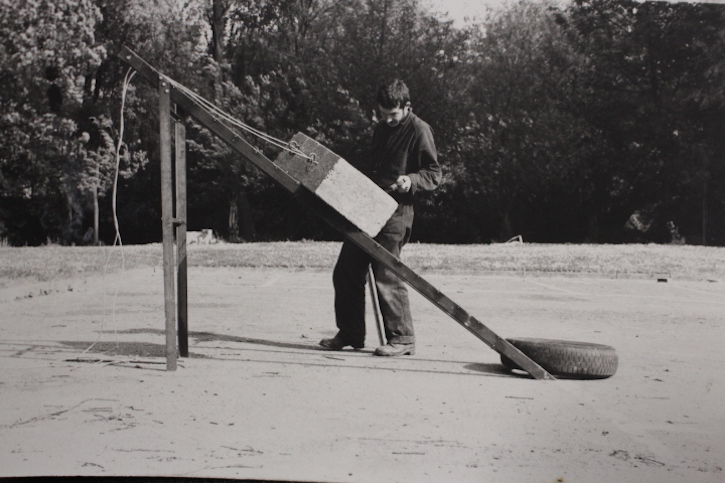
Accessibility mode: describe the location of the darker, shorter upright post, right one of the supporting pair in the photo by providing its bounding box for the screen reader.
[174,119,189,357]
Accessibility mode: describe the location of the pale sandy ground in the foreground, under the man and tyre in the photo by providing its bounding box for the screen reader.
[0,268,725,483]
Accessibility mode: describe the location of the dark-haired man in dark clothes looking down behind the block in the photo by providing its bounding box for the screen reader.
[320,80,441,356]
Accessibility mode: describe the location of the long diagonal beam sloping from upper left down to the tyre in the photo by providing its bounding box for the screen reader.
[119,47,555,379]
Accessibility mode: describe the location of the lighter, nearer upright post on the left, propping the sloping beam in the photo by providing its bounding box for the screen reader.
[159,77,178,371]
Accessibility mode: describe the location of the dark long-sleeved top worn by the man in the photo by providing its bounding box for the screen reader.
[364,112,442,203]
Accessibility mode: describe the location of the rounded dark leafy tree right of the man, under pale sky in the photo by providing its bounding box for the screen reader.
[444,1,590,241]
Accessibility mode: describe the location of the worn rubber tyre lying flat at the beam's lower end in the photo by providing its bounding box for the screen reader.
[501,338,619,379]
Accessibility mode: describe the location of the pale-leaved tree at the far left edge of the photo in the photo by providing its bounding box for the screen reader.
[0,0,104,243]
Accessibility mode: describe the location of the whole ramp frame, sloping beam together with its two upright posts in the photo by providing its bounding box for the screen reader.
[119,47,555,379]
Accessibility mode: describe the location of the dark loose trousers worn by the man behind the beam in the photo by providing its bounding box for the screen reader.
[332,204,415,344]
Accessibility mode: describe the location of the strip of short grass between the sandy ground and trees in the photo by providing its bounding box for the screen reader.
[0,242,725,287]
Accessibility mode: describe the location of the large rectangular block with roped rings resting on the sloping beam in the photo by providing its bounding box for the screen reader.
[275,133,398,237]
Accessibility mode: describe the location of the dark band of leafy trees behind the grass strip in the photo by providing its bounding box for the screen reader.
[0,0,725,245]
